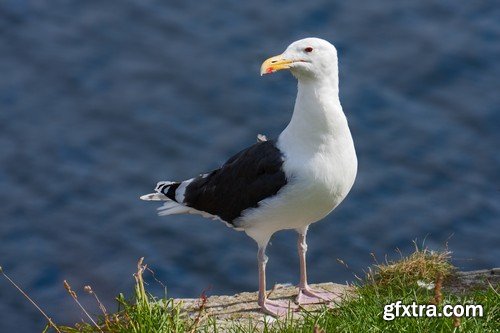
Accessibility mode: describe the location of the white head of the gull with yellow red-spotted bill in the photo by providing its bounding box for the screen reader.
[260,38,338,81]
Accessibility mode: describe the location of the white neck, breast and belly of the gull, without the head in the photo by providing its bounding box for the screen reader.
[236,76,357,245]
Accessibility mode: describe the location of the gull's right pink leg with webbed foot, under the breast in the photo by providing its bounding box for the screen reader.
[296,227,335,304]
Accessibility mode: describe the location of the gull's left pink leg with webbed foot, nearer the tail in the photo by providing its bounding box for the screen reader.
[257,247,297,317]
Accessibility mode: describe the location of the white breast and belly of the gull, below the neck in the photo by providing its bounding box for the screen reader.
[239,126,357,245]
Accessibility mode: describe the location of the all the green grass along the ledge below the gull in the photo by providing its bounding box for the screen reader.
[1,248,500,333]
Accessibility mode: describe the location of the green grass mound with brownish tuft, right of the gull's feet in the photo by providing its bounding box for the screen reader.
[233,248,500,333]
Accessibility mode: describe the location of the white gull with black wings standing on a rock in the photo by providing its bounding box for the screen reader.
[140,38,357,316]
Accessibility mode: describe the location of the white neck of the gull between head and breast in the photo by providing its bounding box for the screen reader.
[280,78,350,148]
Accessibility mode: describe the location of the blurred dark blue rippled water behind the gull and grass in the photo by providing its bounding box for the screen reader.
[0,0,500,332]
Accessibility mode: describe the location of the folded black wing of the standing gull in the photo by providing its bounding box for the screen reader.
[183,141,287,223]
